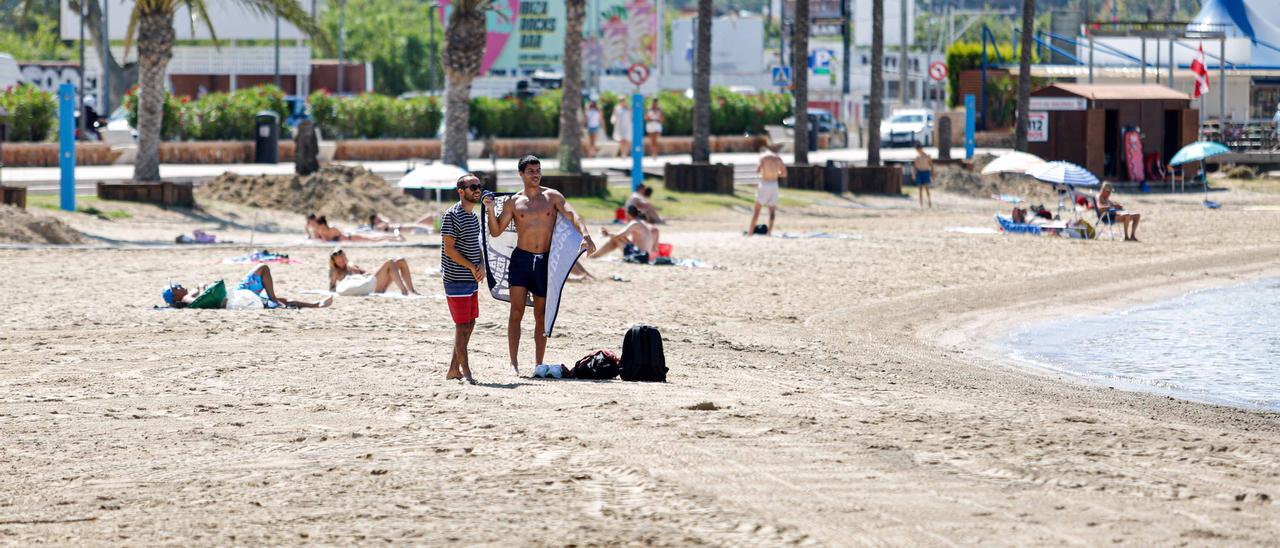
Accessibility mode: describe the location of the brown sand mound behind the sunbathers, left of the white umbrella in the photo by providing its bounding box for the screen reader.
[200,165,426,223]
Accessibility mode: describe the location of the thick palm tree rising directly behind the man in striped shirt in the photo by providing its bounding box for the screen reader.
[440,0,493,169]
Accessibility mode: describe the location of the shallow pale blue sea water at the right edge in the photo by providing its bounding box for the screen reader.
[1006,278,1280,411]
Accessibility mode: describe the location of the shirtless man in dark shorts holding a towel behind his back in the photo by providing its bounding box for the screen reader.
[484,155,595,375]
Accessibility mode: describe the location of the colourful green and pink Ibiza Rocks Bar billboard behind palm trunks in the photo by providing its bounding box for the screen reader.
[440,0,658,74]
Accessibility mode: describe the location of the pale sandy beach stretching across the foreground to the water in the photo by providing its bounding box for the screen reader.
[0,183,1280,547]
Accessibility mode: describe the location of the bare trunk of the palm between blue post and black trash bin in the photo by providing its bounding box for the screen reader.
[133,13,174,183]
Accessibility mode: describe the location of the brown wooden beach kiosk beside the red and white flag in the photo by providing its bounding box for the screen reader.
[1027,83,1199,182]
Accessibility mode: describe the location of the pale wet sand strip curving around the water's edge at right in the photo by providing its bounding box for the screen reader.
[934,261,1280,416]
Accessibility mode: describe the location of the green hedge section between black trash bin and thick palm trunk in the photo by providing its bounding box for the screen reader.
[307,91,443,138]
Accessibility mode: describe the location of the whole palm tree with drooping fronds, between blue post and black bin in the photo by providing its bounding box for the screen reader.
[124,0,323,182]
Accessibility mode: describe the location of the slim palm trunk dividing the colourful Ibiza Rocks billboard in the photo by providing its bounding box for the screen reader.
[556,0,586,173]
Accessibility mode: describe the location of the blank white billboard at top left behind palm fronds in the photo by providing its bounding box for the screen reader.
[60,0,306,40]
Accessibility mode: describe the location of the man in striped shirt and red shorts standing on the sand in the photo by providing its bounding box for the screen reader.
[440,173,485,384]
